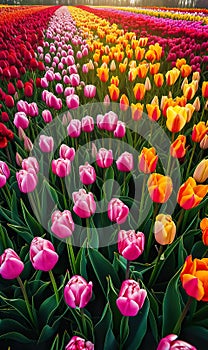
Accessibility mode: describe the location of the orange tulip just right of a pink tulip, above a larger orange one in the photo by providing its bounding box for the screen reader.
[138,147,158,174]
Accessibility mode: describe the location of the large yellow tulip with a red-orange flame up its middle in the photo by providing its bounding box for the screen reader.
[166,106,187,132]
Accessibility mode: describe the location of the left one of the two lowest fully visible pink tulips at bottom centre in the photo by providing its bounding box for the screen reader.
[64,275,93,309]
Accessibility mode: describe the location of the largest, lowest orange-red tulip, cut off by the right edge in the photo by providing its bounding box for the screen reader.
[180,255,208,301]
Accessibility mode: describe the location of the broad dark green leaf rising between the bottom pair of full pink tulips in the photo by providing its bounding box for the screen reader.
[88,249,120,295]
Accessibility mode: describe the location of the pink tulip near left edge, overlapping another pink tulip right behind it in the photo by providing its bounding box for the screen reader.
[16,168,38,193]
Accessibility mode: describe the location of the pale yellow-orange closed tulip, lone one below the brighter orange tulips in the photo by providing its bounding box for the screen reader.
[154,214,176,245]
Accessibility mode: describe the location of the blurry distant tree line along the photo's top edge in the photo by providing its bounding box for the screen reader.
[1,0,208,8]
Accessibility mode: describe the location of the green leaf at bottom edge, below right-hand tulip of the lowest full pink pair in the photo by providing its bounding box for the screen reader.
[124,298,150,350]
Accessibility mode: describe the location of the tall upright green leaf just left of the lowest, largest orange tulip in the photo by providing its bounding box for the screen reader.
[162,270,181,337]
